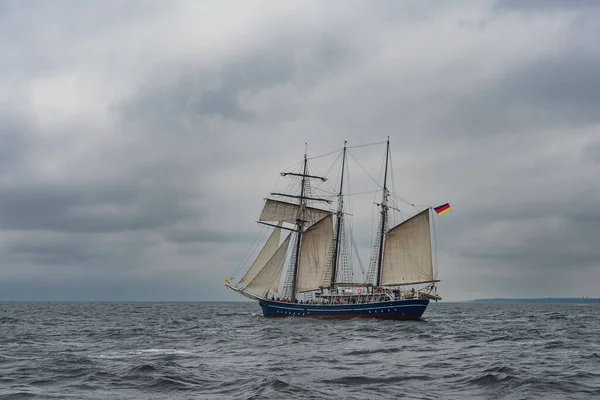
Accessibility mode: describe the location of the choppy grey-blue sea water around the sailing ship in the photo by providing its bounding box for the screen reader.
[0,302,600,399]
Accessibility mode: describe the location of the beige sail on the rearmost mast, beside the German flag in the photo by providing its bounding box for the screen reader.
[381,209,434,285]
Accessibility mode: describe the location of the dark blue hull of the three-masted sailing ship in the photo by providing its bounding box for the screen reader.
[259,299,429,320]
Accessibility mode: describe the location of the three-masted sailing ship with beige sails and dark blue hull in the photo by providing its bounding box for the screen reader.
[225,137,450,320]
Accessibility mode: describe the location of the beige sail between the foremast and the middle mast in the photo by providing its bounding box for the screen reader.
[296,214,333,292]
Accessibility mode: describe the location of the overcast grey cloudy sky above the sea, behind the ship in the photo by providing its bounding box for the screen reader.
[0,0,600,301]
